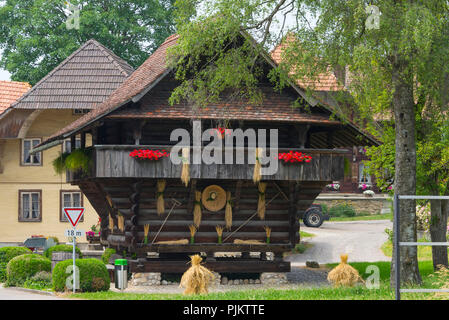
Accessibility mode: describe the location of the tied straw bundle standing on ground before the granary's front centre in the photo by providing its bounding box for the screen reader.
[179,254,215,294]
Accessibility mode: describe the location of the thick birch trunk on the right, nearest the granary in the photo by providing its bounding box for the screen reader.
[390,55,421,285]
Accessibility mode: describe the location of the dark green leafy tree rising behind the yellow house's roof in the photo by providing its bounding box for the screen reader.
[0,0,174,84]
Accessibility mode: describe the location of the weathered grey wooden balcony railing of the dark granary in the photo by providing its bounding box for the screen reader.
[67,145,347,182]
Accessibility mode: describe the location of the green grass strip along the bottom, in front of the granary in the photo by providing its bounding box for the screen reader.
[69,261,448,300]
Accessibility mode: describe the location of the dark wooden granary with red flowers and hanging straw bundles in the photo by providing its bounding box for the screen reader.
[36,35,376,273]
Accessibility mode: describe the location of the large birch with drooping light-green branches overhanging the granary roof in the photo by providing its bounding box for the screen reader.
[172,0,449,283]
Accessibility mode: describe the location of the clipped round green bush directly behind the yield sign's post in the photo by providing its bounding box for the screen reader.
[52,258,111,292]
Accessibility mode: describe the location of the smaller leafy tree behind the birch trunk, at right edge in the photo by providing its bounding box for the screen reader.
[367,112,449,270]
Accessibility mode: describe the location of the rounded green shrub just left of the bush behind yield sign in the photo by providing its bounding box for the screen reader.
[6,253,51,286]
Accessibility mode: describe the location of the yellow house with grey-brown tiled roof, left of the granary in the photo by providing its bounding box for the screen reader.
[0,40,133,246]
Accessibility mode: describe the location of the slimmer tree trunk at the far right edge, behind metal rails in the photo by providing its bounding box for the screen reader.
[430,200,449,270]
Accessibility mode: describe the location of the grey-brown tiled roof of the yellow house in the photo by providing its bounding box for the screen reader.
[11,39,134,109]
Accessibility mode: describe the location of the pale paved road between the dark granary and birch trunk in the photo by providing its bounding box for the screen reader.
[285,220,392,266]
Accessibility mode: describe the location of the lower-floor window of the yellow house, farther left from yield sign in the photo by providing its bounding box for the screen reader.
[19,190,42,222]
